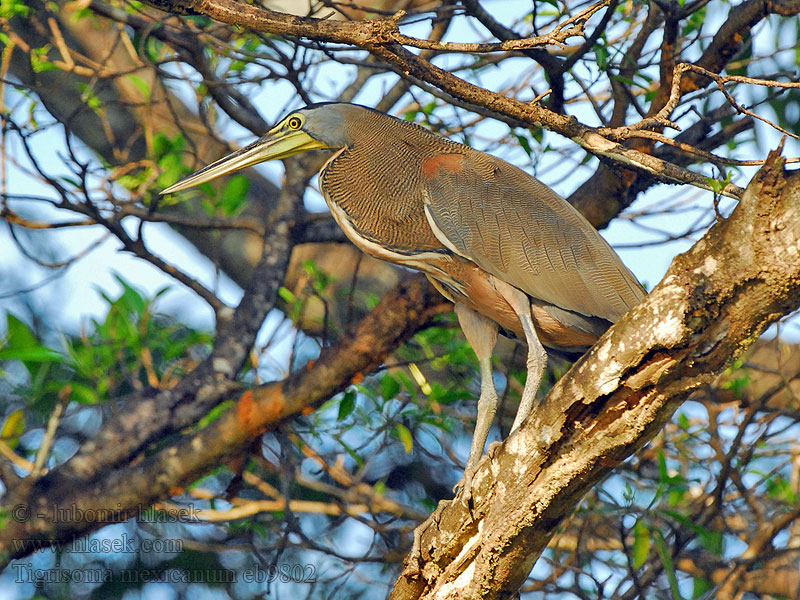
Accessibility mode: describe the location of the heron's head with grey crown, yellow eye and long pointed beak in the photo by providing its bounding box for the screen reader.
[161,103,356,194]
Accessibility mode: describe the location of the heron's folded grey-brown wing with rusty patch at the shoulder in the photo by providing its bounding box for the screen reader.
[422,151,644,322]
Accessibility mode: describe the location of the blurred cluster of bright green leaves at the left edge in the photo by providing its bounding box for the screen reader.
[0,275,211,418]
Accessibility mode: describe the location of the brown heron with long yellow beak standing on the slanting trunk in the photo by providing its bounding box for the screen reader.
[162,103,644,493]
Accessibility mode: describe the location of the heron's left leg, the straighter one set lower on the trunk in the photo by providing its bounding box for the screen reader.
[456,303,497,495]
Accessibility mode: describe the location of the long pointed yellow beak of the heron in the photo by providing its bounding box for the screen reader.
[161,127,327,194]
